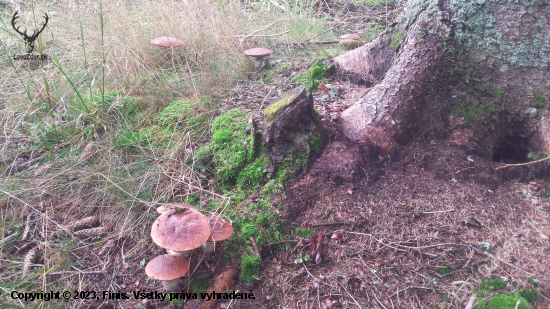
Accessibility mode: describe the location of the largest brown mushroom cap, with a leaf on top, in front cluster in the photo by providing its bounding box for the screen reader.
[151,208,210,251]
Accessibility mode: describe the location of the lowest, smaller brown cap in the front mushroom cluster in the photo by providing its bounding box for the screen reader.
[145,254,189,281]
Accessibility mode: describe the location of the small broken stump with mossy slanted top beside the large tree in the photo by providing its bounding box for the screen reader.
[262,86,324,172]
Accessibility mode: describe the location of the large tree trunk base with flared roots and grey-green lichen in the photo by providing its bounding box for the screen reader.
[335,0,550,163]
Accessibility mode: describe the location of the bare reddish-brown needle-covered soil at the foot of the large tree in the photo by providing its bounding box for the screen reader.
[242,125,550,308]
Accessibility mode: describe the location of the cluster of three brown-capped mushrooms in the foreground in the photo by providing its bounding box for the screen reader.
[145,203,233,292]
